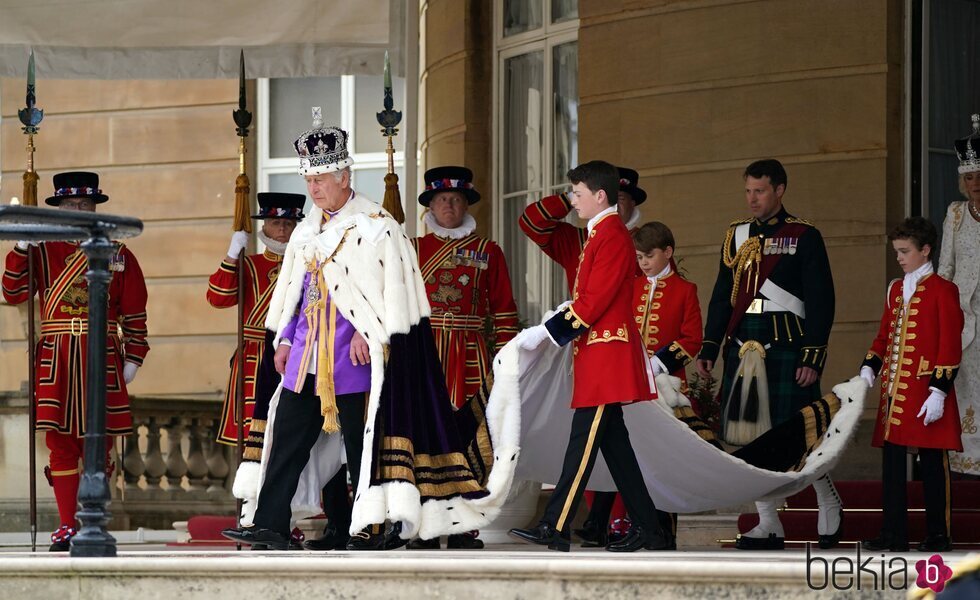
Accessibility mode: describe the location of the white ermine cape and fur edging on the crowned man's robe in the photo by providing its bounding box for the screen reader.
[263,195,520,538]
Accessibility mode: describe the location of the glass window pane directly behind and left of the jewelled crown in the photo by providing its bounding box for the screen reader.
[269,77,341,158]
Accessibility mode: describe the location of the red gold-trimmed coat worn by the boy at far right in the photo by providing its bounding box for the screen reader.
[864,274,963,451]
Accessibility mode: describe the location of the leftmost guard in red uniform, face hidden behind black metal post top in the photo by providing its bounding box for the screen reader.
[2,171,150,552]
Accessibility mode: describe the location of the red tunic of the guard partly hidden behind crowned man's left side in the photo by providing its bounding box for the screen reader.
[207,250,282,445]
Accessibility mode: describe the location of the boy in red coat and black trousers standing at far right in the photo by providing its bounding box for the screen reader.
[861,217,963,552]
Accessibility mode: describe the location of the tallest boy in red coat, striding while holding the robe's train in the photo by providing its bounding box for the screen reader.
[510,161,669,552]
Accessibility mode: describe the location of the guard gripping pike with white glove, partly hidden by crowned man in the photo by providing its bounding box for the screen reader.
[207,192,306,446]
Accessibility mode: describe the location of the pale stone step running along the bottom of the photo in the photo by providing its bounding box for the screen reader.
[0,546,966,600]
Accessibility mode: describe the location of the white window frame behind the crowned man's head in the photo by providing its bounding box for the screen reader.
[255,75,407,202]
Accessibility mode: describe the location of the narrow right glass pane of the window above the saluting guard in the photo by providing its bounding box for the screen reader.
[551,42,578,183]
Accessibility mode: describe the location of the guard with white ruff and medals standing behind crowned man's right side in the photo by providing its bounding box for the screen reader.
[408,166,517,550]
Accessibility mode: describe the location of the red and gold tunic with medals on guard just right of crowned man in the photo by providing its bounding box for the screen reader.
[413,233,517,407]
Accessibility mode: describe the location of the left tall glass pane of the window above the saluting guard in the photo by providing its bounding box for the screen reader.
[502,51,544,194]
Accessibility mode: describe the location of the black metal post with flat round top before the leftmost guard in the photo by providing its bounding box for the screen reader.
[0,206,143,556]
